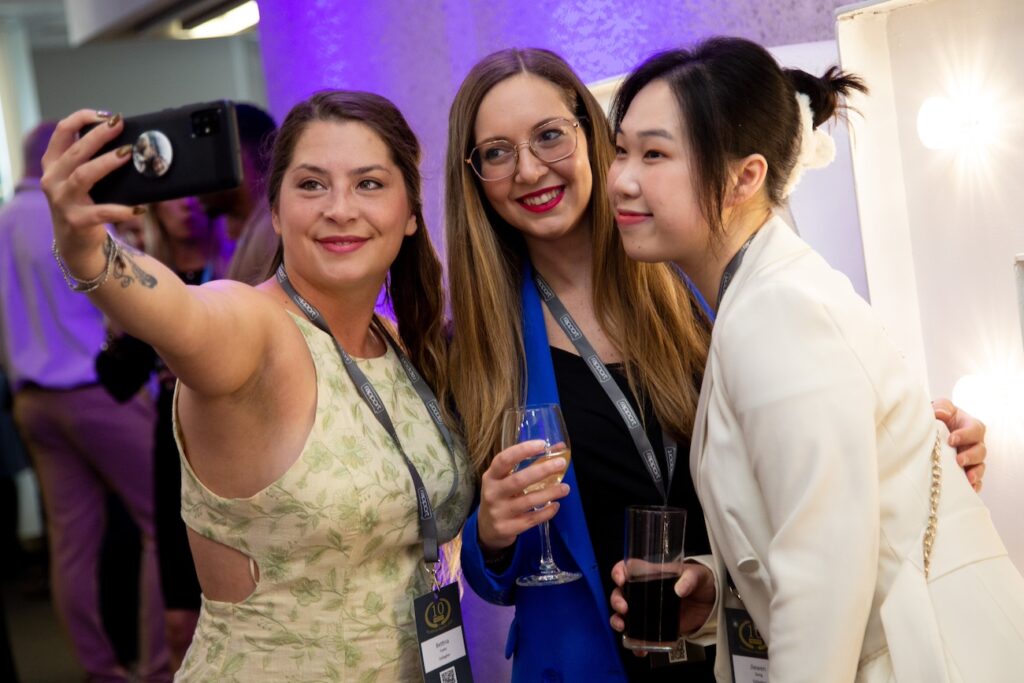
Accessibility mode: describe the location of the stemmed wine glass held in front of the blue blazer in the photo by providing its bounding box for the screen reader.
[502,403,583,586]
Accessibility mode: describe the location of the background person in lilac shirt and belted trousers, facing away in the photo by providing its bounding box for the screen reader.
[0,123,170,681]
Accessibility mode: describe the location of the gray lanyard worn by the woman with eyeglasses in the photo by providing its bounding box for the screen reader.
[534,270,676,505]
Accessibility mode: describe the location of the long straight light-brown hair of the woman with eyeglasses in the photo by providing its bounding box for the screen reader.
[445,49,708,472]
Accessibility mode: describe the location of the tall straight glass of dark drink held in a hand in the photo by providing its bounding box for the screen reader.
[623,506,686,652]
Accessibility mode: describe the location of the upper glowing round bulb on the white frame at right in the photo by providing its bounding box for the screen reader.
[918,96,998,150]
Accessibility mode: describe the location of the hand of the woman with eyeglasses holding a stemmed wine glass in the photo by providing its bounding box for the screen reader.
[477,440,569,552]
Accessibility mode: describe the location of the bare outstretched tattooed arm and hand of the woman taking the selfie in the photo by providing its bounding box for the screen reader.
[42,110,280,396]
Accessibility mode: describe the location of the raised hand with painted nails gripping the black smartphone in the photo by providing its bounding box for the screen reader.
[42,110,137,272]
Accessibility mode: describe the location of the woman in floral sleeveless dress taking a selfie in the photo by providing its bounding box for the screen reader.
[43,91,471,681]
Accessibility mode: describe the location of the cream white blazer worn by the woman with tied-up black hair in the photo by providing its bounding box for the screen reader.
[690,217,1024,683]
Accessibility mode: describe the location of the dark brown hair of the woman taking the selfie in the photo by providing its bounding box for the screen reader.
[267,90,446,401]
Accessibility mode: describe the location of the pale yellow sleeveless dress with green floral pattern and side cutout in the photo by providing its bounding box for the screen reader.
[175,315,473,683]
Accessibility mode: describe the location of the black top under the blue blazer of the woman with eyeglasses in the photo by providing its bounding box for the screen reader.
[551,347,715,683]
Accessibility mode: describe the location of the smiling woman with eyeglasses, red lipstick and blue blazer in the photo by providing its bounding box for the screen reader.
[446,49,984,683]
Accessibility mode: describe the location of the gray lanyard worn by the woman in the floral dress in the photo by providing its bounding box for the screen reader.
[276,263,459,564]
